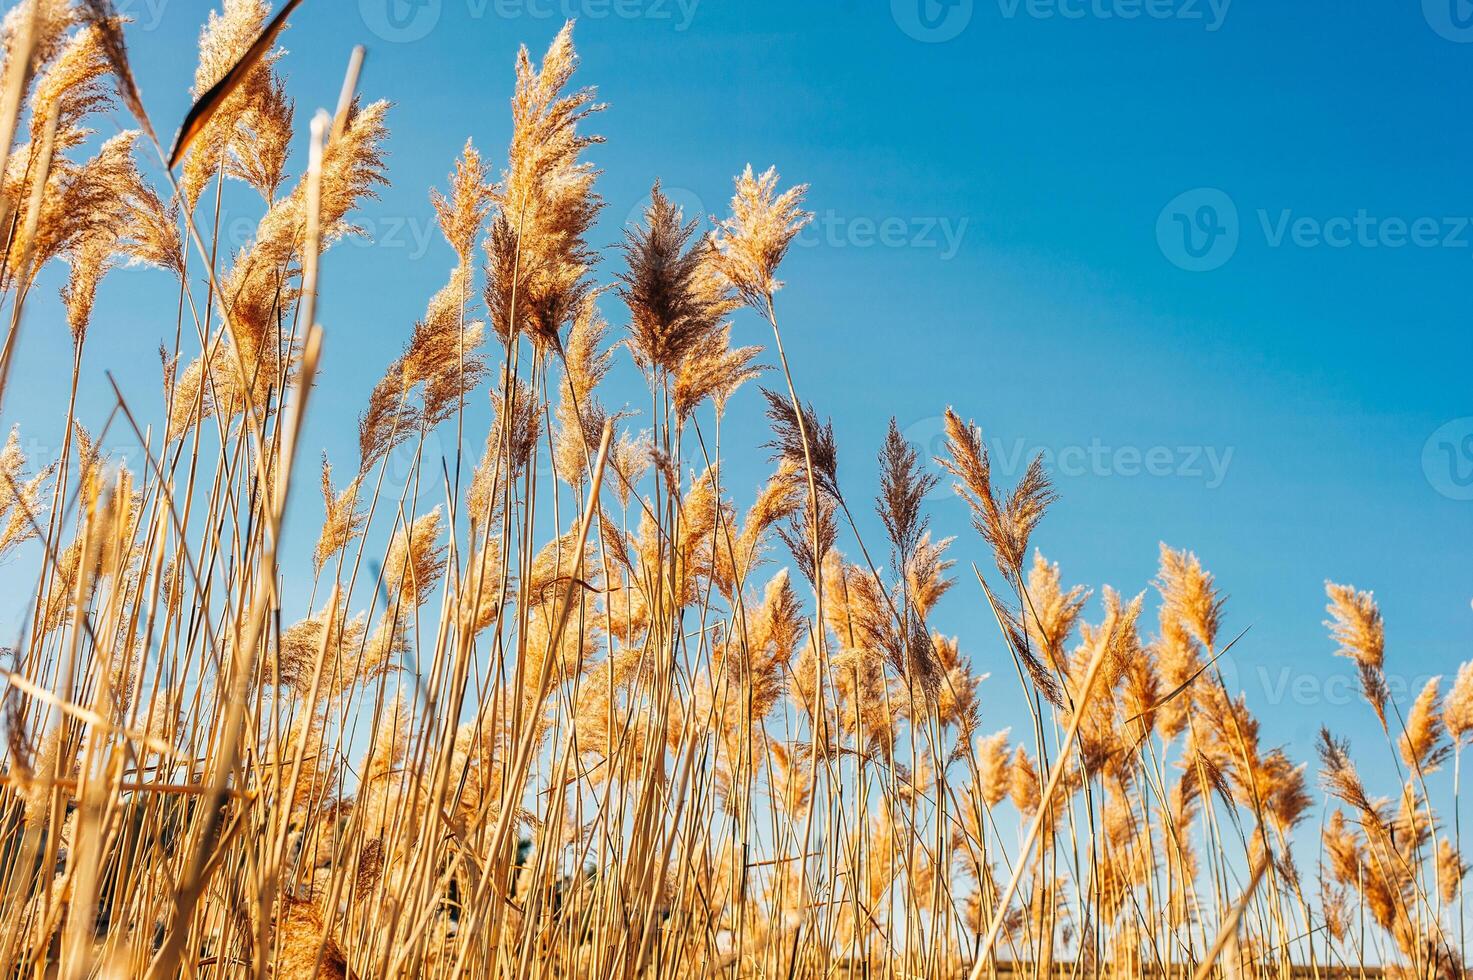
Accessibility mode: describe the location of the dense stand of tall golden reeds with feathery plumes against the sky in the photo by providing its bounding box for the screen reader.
[0,0,1473,979]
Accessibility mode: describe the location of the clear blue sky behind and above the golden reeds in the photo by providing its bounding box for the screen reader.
[0,0,1473,793]
